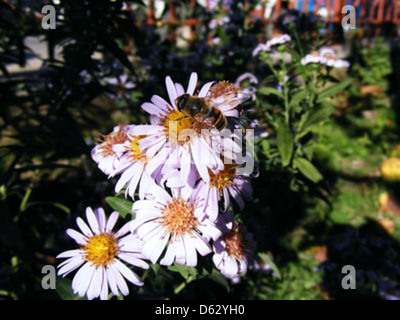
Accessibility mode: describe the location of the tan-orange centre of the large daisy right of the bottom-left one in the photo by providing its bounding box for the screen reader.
[160,198,199,235]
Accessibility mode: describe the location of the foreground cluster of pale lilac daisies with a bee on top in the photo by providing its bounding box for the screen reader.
[58,73,255,299]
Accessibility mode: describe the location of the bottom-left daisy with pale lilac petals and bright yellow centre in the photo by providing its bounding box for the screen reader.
[57,207,149,300]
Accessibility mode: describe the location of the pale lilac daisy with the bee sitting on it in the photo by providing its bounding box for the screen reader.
[131,73,247,181]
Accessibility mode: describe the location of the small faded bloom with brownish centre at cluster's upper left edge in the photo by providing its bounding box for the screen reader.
[92,125,129,175]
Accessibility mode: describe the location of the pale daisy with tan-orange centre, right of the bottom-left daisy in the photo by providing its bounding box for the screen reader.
[131,188,221,267]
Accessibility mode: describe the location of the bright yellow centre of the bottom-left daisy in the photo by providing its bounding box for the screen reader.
[83,233,119,267]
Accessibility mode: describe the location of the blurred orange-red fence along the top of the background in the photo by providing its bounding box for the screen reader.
[146,0,400,36]
